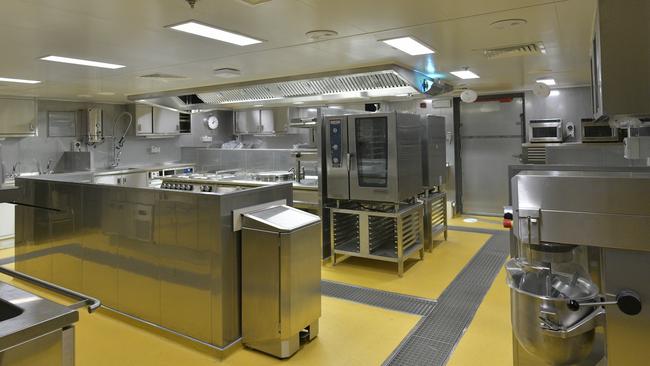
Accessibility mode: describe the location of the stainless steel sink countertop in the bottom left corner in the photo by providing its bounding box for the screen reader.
[0,282,79,351]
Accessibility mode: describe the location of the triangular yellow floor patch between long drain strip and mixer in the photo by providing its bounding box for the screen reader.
[447,269,512,366]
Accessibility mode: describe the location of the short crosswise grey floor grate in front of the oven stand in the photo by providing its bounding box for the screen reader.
[321,280,436,316]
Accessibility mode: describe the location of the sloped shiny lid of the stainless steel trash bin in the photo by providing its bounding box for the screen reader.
[242,205,320,232]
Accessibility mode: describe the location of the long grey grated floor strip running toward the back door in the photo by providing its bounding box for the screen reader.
[384,232,509,366]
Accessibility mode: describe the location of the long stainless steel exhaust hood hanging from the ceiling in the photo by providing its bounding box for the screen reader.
[128,64,452,111]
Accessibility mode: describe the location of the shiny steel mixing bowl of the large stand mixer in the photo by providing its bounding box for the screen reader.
[506,259,598,366]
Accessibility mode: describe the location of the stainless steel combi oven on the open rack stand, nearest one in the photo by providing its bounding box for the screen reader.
[324,112,422,203]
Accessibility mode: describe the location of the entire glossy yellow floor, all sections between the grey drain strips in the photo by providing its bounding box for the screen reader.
[0,223,512,366]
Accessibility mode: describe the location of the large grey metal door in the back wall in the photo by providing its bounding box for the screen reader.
[460,96,524,216]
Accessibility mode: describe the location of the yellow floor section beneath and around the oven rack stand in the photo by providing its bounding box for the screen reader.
[321,230,490,299]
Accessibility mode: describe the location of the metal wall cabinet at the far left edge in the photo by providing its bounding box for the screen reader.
[0,98,38,136]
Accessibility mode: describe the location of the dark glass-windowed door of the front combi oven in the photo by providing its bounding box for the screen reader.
[348,113,399,202]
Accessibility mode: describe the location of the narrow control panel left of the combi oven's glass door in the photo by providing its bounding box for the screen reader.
[324,116,350,200]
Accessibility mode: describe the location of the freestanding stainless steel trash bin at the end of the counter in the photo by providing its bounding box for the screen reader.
[242,206,321,358]
